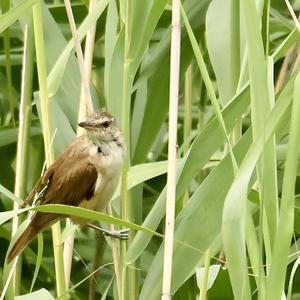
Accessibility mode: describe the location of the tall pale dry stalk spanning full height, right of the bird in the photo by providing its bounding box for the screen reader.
[162,0,180,300]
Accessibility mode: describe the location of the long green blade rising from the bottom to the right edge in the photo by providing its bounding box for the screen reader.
[266,74,300,299]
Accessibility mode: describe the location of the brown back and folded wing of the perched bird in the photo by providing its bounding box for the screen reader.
[26,137,97,209]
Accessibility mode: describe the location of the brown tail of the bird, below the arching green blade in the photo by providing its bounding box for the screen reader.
[7,213,59,263]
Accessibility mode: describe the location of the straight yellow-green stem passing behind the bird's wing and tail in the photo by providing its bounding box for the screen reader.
[33,1,66,298]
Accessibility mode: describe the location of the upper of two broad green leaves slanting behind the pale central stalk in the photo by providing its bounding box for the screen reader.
[128,87,250,262]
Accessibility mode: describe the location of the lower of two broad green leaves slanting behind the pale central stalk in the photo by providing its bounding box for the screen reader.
[141,131,251,300]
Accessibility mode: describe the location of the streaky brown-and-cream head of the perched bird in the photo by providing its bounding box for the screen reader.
[78,112,123,144]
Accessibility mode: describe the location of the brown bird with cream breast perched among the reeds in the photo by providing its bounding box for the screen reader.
[7,111,126,263]
